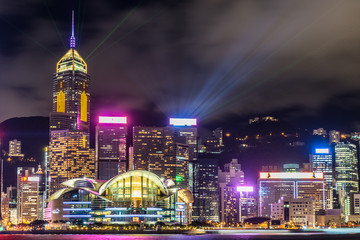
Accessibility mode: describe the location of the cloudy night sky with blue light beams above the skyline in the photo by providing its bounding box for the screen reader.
[0,0,360,130]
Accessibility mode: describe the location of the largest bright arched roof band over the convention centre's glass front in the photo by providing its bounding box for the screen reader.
[99,170,169,196]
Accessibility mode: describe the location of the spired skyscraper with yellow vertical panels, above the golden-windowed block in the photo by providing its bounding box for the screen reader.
[50,12,90,133]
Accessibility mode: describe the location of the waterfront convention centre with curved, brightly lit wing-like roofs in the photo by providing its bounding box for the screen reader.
[46,170,194,225]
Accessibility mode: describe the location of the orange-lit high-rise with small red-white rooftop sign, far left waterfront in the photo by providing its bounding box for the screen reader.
[17,167,42,223]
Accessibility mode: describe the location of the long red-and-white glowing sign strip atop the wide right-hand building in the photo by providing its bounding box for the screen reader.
[260,172,324,179]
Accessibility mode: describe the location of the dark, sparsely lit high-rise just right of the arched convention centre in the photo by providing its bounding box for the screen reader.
[197,158,220,222]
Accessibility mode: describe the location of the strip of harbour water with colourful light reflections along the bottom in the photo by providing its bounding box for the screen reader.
[0,233,360,240]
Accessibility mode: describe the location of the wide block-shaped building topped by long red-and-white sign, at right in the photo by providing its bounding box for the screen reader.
[258,172,325,217]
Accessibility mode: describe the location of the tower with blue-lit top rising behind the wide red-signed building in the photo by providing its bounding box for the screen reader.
[310,148,334,209]
